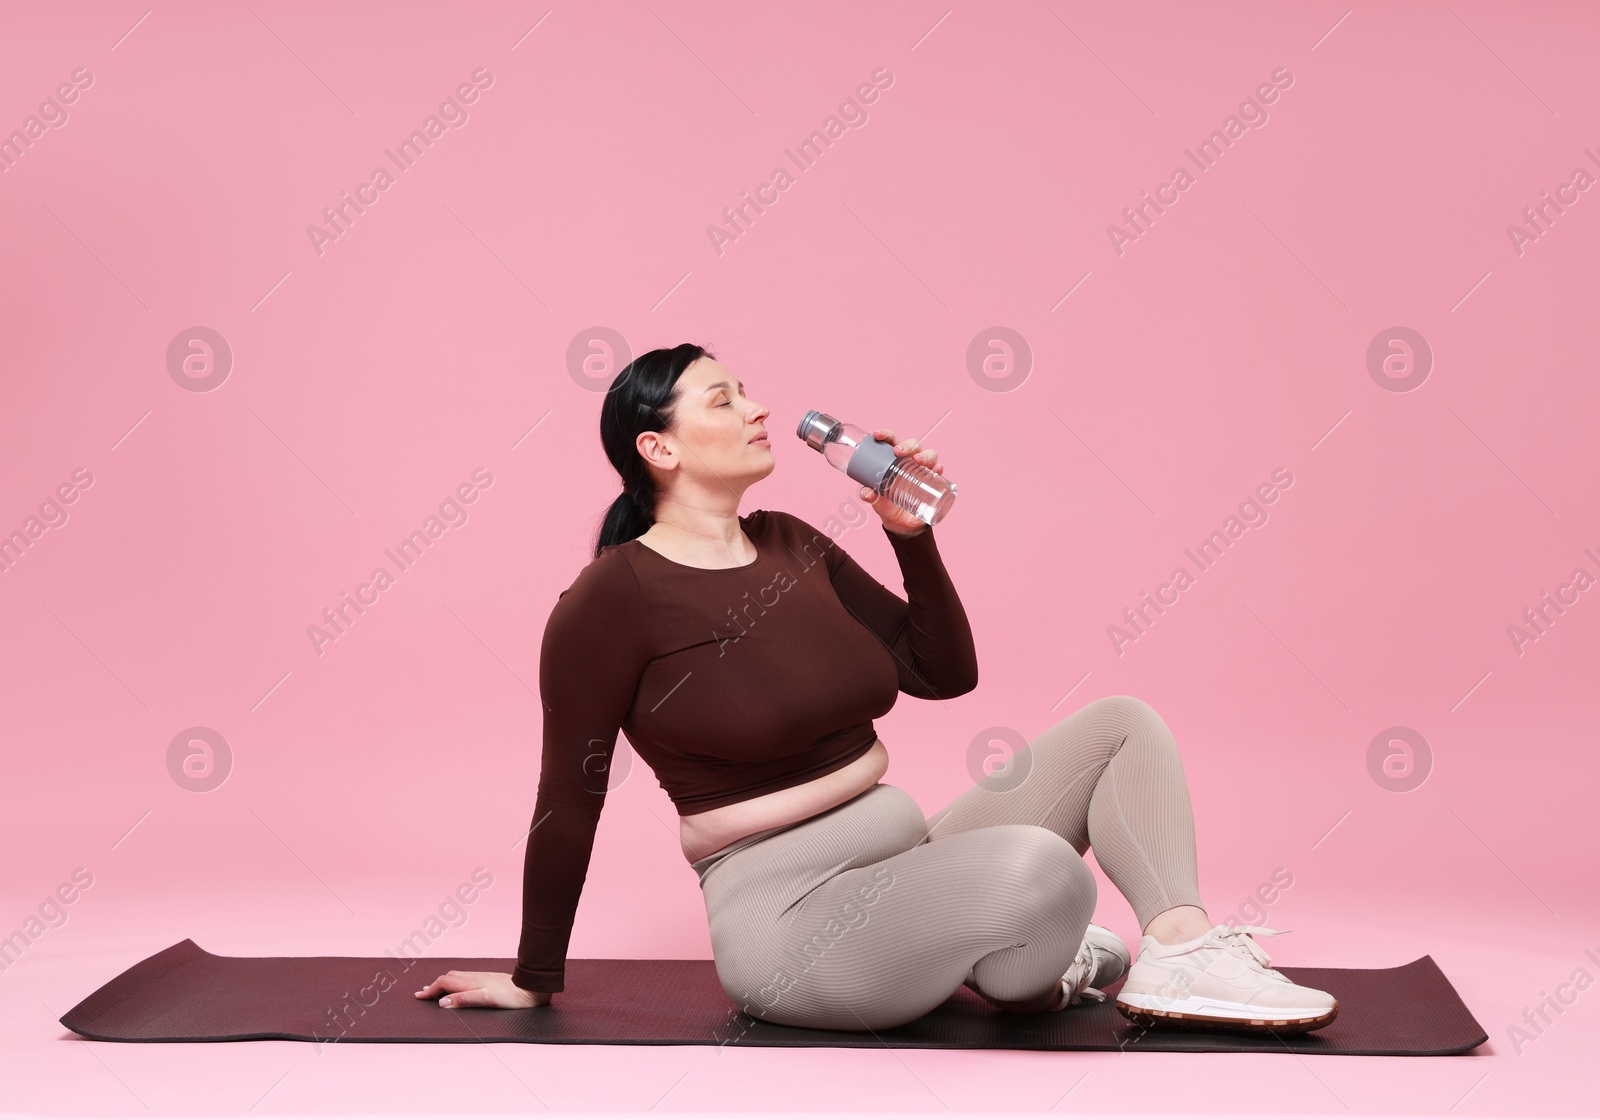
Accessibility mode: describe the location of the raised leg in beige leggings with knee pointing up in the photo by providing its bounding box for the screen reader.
[928,696,1211,940]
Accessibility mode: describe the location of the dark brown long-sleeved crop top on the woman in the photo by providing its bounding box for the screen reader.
[512,509,978,992]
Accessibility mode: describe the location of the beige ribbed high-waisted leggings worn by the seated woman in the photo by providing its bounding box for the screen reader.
[693,696,1200,1030]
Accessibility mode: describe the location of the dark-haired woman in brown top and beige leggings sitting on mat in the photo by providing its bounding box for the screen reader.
[416,344,1338,1034]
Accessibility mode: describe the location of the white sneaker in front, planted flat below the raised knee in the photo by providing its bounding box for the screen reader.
[1117,925,1339,1034]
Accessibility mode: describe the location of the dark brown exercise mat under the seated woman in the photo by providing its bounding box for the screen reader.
[61,938,1488,1056]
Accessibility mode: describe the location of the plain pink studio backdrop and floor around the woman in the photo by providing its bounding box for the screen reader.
[0,0,1600,1115]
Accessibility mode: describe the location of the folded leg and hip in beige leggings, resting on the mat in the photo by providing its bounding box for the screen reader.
[701,784,1096,1030]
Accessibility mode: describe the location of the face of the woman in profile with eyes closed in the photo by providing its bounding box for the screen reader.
[640,358,778,491]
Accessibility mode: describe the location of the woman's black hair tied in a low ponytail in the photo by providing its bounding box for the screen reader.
[595,342,717,558]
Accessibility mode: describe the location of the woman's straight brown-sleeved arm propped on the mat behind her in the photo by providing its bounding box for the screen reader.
[424,552,650,1006]
